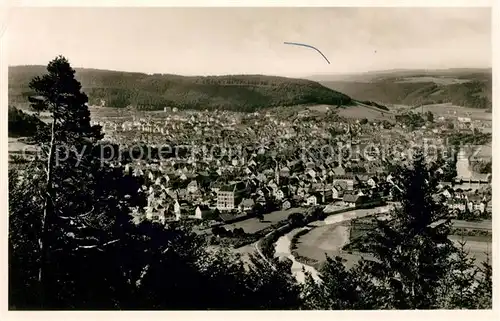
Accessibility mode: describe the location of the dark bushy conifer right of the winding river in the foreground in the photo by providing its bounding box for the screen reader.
[365,151,454,309]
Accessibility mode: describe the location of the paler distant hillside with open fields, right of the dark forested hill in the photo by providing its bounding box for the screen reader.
[310,69,492,110]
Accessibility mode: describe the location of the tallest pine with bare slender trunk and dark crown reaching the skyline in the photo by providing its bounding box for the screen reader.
[29,57,100,301]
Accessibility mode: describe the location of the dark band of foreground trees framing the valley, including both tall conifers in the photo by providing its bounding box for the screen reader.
[9,57,491,309]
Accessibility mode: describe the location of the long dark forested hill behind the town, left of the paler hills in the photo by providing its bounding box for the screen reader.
[9,66,352,112]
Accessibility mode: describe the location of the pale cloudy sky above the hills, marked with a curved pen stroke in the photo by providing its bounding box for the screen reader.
[6,7,492,76]
